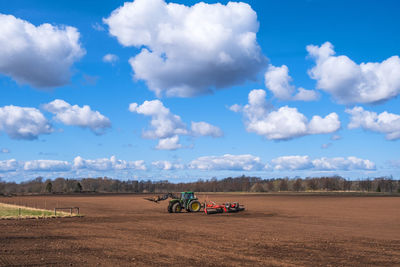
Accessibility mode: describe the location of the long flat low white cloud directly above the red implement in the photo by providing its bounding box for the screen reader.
[189,154,264,171]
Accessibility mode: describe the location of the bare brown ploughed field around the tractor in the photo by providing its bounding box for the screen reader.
[0,194,400,266]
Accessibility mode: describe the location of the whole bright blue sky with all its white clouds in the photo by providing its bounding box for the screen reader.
[0,0,400,182]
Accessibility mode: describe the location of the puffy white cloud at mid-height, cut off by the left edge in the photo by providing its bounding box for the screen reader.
[0,105,53,140]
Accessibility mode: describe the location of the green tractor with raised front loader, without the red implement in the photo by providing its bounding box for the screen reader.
[145,191,202,213]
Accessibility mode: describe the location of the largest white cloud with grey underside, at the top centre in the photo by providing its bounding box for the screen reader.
[104,0,266,97]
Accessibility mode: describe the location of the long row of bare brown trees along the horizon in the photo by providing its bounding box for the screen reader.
[0,175,400,195]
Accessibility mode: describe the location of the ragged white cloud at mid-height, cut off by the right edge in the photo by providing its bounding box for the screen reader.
[346,107,400,140]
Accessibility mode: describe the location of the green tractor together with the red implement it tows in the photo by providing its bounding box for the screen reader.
[145,191,244,215]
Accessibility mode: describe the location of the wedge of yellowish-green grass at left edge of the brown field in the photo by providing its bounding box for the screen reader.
[0,203,81,219]
